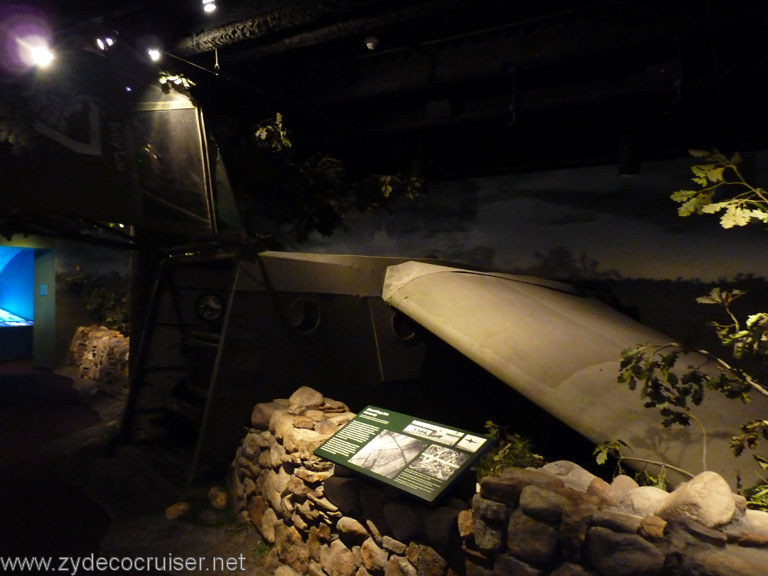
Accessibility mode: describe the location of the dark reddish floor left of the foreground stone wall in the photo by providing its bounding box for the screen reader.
[0,362,266,576]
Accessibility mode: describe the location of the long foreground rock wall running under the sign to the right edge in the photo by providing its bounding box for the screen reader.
[228,387,768,576]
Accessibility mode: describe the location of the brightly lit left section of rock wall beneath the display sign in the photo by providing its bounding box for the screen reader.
[228,387,468,576]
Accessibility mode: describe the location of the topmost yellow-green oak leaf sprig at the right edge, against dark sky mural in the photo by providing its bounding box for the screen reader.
[671,150,768,228]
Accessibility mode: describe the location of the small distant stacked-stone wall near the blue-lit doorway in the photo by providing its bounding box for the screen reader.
[69,324,130,395]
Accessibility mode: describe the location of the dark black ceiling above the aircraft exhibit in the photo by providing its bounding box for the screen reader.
[12,0,768,178]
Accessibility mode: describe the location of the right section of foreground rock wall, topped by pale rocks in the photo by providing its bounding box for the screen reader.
[459,461,768,576]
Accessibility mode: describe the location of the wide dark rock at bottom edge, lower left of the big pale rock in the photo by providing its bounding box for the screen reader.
[586,527,664,576]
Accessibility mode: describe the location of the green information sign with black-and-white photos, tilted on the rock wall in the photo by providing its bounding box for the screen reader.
[315,406,493,502]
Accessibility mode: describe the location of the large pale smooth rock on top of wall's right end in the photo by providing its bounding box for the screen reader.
[656,471,736,528]
